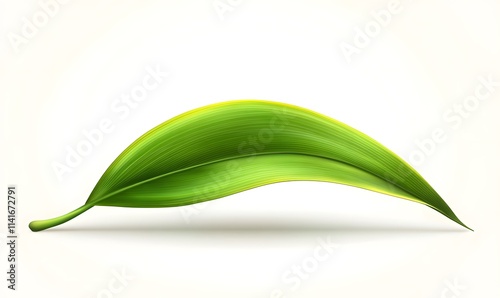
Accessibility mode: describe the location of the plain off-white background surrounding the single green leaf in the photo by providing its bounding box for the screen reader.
[0,0,500,298]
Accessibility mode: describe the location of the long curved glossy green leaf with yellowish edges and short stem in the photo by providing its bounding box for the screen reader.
[29,100,468,231]
